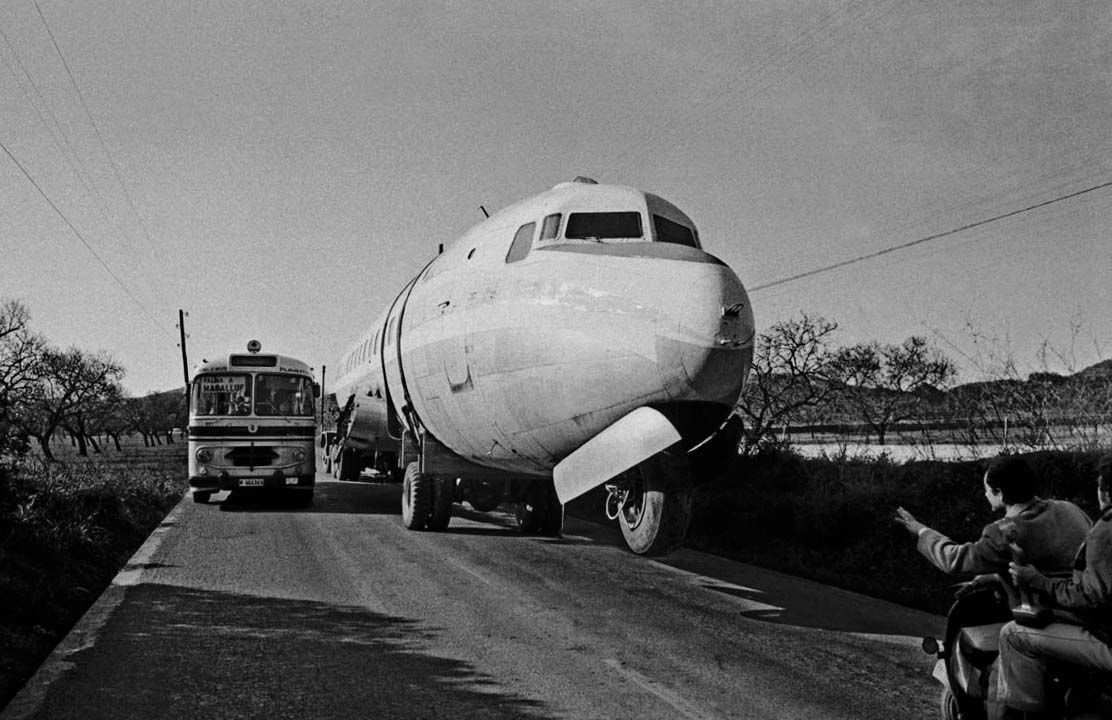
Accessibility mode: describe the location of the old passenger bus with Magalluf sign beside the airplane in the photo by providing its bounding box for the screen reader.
[189,341,320,505]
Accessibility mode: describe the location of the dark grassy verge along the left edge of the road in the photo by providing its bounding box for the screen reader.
[0,442,187,708]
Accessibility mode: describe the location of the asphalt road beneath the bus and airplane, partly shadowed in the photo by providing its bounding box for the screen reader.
[0,465,942,720]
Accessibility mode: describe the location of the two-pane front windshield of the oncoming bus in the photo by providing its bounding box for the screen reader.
[190,373,314,417]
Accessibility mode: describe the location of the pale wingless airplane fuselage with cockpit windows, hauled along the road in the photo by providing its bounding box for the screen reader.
[324,183,754,551]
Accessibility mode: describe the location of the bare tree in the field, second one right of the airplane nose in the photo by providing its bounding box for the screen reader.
[831,336,957,445]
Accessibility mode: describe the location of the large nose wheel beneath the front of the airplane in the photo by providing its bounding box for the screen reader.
[616,452,692,555]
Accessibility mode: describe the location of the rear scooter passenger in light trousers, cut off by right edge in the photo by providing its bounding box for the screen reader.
[996,454,1112,718]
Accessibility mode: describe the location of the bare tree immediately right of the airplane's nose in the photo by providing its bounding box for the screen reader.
[738,313,837,453]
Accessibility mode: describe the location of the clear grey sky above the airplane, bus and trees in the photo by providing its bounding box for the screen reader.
[0,0,1112,395]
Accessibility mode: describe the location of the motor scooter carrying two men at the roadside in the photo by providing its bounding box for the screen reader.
[923,560,1112,720]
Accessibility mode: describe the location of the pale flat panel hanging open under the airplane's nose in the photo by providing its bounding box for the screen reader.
[553,407,681,503]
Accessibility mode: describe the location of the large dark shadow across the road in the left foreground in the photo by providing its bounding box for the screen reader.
[36,584,552,720]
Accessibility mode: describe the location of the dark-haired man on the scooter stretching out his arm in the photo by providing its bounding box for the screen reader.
[895,455,1091,574]
